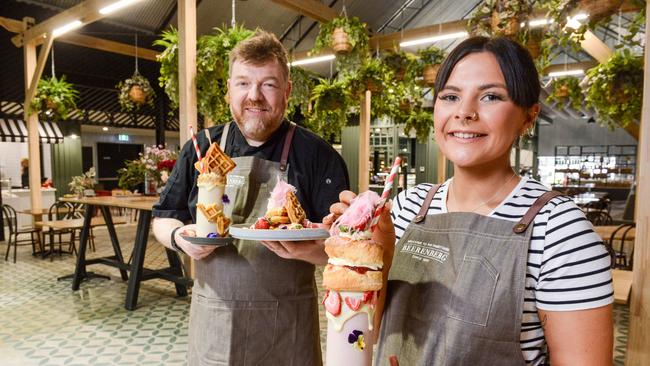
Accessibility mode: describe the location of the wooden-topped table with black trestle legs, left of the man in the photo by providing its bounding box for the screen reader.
[61,196,192,310]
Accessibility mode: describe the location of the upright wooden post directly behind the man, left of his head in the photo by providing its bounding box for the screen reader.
[178,0,198,146]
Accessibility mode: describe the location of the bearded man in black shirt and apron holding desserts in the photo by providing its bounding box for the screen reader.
[153,31,349,365]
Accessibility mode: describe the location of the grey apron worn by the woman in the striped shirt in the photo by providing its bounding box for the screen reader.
[375,186,558,366]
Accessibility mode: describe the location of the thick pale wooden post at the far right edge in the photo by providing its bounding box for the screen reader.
[626,3,650,366]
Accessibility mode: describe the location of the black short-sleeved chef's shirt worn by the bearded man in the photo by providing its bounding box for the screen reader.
[153,121,350,223]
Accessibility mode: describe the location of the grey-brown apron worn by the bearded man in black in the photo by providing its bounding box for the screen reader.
[188,123,321,366]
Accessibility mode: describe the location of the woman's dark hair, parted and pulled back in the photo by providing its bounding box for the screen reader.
[434,37,541,108]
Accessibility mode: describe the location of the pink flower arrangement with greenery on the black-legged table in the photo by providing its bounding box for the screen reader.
[117,145,178,193]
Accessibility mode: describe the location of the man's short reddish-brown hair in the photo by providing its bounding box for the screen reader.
[228,29,289,80]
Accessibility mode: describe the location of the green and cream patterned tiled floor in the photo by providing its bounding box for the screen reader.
[0,225,629,366]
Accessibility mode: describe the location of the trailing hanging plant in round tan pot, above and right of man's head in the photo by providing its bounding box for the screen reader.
[310,16,370,77]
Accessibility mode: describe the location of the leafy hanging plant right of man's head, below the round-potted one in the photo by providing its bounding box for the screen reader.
[305,79,351,139]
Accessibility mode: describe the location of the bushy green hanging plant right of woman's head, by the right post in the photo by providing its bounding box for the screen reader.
[586,49,644,129]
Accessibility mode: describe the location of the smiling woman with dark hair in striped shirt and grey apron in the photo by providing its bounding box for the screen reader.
[324,37,613,365]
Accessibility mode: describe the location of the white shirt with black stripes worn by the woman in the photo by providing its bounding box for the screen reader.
[391,178,614,365]
